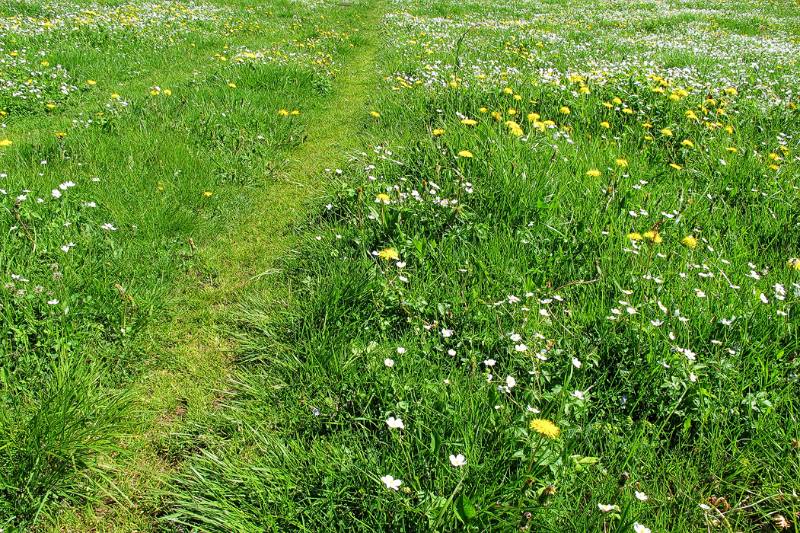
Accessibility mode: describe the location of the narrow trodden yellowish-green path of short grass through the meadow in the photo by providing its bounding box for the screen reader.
[54,1,383,531]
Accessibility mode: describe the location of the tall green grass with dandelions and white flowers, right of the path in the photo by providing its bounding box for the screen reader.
[166,2,800,531]
